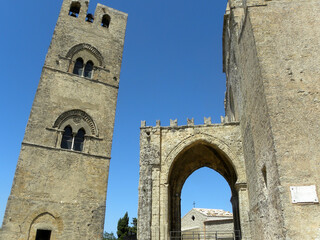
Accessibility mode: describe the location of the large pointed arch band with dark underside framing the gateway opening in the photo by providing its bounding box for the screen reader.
[167,137,241,236]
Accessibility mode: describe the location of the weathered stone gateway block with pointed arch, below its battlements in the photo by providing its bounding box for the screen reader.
[138,123,250,240]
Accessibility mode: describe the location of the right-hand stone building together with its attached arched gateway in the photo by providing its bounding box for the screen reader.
[138,0,320,240]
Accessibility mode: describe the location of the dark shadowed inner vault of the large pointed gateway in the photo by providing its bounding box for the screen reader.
[168,141,241,239]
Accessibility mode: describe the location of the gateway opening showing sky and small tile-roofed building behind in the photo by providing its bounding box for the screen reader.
[181,167,234,240]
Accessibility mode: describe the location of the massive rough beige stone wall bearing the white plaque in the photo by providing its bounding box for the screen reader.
[224,1,320,239]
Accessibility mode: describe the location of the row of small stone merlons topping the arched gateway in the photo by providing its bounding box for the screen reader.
[141,116,239,129]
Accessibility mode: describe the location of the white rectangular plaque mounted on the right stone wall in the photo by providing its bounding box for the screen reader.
[290,185,319,203]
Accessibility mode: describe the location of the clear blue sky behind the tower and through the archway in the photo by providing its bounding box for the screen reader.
[0,0,231,236]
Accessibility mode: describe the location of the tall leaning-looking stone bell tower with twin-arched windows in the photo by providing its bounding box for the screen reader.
[0,0,127,240]
